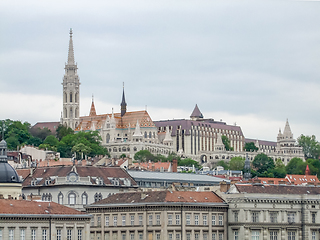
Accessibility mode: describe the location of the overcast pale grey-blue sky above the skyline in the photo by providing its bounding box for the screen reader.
[0,0,320,141]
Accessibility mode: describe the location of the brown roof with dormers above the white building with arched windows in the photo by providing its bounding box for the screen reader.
[22,166,137,187]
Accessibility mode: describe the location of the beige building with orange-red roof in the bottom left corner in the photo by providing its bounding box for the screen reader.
[0,199,91,240]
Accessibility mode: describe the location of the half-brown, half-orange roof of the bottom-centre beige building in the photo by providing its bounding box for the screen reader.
[92,191,224,205]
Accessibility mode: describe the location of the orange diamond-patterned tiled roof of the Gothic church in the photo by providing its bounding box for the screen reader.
[75,111,155,131]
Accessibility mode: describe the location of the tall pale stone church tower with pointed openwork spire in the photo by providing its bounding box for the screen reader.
[60,29,80,130]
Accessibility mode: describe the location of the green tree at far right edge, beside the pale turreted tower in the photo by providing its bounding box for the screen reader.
[298,134,320,159]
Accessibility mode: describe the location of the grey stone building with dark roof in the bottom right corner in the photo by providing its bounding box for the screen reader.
[224,184,320,240]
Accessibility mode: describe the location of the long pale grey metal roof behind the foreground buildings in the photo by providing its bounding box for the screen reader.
[128,171,230,184]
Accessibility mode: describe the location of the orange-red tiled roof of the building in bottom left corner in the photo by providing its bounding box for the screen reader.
[0,199,85,215]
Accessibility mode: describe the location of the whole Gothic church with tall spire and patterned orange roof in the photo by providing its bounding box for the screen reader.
[60,30,173,158]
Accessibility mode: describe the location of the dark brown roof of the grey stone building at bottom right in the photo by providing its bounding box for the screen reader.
[235,184,320,195]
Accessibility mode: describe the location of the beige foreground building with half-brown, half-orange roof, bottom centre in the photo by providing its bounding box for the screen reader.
[86,191,227,240]
